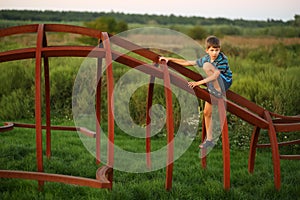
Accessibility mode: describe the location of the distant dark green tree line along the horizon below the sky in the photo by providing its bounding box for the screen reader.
[0,10,300,28]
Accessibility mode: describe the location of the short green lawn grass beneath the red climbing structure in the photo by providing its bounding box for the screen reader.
[0,124,300,200]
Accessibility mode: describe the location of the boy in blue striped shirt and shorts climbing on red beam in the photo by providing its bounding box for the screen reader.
[159,36,232,148]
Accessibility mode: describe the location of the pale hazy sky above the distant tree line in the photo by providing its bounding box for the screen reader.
[0,0,300,21]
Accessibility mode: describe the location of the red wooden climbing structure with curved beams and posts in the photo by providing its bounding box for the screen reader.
[0,24,300,190]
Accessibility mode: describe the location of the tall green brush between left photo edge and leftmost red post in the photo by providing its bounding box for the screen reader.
[0,61,34,120]
